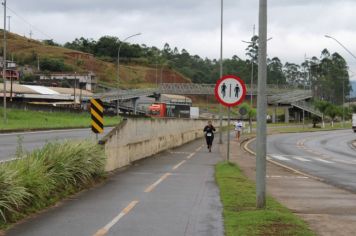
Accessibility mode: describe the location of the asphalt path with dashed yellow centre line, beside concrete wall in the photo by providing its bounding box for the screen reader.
[6,137,224,236]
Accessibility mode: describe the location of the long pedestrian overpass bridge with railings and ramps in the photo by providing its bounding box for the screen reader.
[94,83,322,120]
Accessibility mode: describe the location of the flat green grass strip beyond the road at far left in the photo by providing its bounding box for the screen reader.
[0,108,122,131]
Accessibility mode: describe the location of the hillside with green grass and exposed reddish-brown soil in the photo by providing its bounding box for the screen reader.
[0,31,190,88]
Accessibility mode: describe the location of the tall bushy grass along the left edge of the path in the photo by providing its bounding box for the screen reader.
[0,141,105,226]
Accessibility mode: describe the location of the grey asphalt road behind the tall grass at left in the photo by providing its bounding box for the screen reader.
[0,127,112,161]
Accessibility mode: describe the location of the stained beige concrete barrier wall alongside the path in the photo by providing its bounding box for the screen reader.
[101,119,225,171]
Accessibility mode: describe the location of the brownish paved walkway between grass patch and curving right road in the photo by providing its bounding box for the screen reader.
[220,140,356,236]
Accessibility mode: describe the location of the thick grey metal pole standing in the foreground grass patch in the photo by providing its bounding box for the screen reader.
[256,0,267,209]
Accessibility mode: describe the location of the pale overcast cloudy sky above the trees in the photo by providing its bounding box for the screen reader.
[7,0,356,80]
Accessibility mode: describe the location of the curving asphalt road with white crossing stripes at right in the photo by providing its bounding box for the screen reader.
[250,129,356,192]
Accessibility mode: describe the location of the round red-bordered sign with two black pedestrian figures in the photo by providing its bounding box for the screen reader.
[215,75,246,107]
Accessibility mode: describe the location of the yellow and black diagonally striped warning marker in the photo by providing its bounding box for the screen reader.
[90,98,104,134]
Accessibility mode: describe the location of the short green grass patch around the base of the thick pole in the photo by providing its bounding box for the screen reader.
[215,162,315,236]
